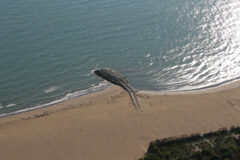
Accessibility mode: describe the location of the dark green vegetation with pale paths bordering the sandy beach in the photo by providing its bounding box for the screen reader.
[139,127,240,160]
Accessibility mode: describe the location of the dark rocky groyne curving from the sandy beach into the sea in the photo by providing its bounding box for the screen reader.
[93,69,140,109]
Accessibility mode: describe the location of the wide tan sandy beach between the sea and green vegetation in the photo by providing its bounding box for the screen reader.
[0,81,240,160]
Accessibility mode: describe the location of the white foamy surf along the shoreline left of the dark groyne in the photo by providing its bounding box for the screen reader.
[0,81,111,117]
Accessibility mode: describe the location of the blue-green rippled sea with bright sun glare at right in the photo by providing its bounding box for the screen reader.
[0,0,240,116]
